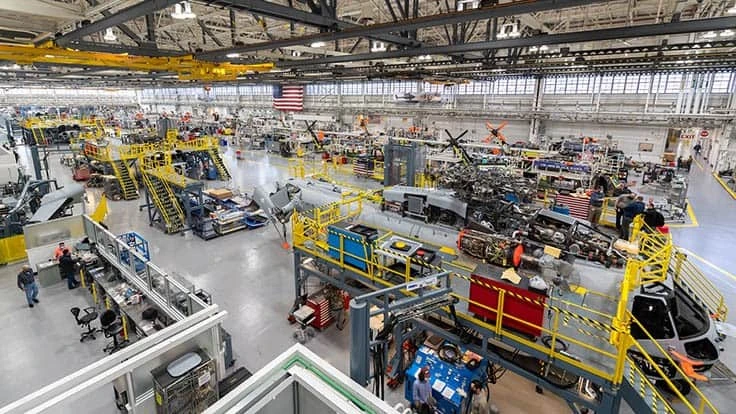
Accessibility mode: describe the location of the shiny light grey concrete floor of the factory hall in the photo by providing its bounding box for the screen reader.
[0,145,736,413]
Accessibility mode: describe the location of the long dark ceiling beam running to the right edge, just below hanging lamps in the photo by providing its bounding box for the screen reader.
[277,17,736,68]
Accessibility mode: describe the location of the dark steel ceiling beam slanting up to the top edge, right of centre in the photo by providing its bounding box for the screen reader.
[198,0,605,59]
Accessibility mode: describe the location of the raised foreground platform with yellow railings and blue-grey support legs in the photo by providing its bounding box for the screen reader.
[292,196,727,413]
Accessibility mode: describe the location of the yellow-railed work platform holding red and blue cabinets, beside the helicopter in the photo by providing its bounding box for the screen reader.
[292,196,727,413]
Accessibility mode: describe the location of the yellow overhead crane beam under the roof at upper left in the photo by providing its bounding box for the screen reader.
[0,44,274,82]
